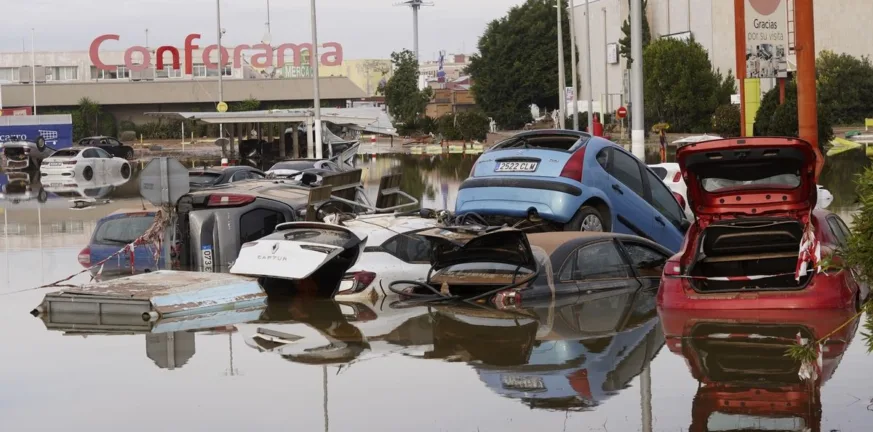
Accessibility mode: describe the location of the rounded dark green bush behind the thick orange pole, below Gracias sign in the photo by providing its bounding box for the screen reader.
[754,80,834,148]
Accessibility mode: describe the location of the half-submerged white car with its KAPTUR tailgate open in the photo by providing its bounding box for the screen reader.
[230,214,439,302]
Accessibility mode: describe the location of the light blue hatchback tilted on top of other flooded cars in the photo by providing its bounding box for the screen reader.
[455,130,690,252]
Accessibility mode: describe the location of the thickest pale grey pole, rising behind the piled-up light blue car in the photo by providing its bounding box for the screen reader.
[631,0,646,161]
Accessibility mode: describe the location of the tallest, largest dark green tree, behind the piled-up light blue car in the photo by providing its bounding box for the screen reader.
[468,0,573,129]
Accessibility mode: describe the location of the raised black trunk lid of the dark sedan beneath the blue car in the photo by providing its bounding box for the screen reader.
[418,226,537,271]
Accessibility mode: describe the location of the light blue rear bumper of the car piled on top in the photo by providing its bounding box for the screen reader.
[455,177,588,223]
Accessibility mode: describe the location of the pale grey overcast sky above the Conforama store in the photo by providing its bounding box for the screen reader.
[0,0,523,60]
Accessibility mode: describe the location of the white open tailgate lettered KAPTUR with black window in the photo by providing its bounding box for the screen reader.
[230,222,366,280]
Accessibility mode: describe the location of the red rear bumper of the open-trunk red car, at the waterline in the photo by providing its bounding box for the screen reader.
[658,271,856,311]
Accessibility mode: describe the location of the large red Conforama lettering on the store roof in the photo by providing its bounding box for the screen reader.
[90,33,343,75]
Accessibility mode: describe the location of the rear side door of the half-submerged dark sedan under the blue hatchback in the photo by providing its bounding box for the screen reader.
[556,240,640,294]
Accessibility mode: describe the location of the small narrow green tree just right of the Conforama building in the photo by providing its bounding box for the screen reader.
[377,50,433,124]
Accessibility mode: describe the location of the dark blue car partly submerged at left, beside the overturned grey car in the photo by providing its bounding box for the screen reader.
[79,210,167,277]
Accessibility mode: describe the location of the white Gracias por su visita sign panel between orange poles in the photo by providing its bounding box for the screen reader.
[745,0,788,78]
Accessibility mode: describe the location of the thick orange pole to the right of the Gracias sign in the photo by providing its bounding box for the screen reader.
[794,0,821,159]
